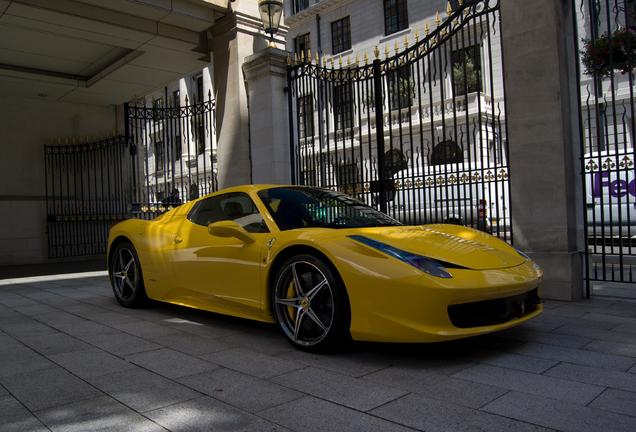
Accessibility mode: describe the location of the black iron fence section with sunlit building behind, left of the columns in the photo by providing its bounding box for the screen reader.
[125,92,217,219]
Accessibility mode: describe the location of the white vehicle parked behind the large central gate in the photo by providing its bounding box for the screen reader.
[388,162,510,237]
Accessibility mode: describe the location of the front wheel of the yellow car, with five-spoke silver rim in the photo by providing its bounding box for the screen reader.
[271,254,351,352]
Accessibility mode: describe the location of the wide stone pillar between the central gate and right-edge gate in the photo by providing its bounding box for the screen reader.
[501,0,584,300]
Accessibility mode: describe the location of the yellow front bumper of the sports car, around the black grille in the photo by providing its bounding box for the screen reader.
[347,261,543,343]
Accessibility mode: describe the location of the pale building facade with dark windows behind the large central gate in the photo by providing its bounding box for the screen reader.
[285,0,510,238]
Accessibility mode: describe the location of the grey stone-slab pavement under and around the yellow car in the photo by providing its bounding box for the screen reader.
[0,274,636,432]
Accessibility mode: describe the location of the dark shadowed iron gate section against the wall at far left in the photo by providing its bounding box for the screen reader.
[44,136,132,258]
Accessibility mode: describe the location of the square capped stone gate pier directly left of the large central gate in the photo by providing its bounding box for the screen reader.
[243,48,291,184]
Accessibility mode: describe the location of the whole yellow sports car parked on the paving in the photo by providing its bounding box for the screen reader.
[108,185,543,350]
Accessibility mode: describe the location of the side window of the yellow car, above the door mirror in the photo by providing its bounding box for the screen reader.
[189,193,269,233]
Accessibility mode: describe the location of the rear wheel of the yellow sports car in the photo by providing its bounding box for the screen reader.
[108,241,148,308]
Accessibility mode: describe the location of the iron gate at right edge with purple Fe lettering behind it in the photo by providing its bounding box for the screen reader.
[573,0,636,296]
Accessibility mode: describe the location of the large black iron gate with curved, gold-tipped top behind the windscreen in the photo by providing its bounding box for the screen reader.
[288,0,512,242]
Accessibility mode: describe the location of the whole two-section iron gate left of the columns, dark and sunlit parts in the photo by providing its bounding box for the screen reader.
[44,93,217,258]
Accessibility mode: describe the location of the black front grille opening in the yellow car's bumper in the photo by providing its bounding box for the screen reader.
[448,288,541,328]
